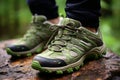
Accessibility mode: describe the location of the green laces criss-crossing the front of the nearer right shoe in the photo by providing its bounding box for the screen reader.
[48,26,77,52]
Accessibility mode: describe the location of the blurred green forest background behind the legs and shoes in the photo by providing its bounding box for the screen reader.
[0,0,120,54]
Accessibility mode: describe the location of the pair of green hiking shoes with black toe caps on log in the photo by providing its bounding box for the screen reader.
[6,16,105,74]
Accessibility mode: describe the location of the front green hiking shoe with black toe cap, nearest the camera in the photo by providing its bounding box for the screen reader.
[32,18,105,74]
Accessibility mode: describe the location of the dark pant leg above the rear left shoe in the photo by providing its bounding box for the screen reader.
[27,0,58,19]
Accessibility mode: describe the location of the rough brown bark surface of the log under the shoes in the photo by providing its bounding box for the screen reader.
[0,40,120,80]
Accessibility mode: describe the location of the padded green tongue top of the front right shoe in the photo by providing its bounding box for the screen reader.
[61,18,82,29]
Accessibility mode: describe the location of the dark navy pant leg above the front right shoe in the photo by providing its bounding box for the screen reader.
[66,0,100,28]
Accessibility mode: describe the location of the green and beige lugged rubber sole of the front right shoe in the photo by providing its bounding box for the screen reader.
[32,44,106,74]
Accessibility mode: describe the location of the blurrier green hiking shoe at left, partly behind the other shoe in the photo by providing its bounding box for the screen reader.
[6,15,57,56]
